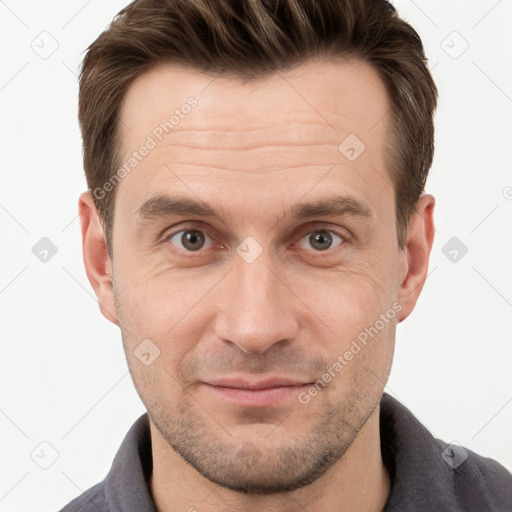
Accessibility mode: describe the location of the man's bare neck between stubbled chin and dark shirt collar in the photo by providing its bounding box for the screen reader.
[150,407,391,512]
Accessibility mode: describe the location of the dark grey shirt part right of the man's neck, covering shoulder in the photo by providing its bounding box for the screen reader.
[380,395,512,512]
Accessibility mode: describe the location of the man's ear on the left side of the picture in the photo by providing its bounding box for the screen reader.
[78,191,119,325]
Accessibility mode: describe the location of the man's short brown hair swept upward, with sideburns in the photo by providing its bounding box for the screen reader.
[79,0,437,257]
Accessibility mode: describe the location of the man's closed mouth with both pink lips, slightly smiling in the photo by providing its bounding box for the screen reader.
[202,377,311,408]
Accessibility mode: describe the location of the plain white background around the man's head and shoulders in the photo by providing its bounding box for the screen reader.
[0,0,512,512]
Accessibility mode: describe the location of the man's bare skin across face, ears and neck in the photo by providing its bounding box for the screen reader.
[79,60,434,512]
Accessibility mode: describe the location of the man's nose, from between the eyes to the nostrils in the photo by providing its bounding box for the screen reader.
[215,251,299,354]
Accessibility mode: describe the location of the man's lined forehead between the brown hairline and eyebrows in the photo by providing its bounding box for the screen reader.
[116,59,391,224]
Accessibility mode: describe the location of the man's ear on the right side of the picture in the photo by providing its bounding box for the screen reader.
[398,194,435,322]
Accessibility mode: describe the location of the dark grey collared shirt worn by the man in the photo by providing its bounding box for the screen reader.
[56,393,512,512]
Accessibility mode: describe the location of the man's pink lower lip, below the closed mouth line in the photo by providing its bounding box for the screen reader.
[205,384,308,407]
